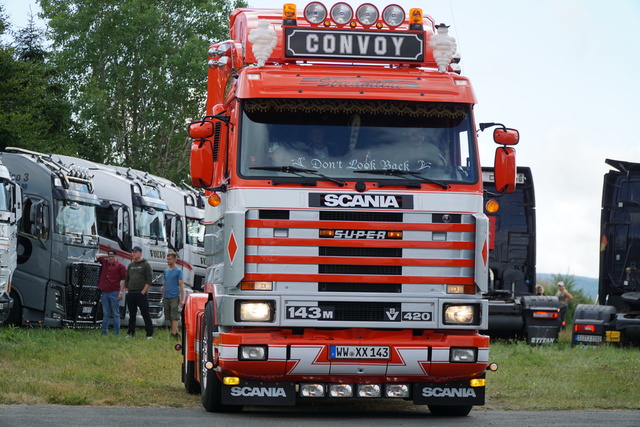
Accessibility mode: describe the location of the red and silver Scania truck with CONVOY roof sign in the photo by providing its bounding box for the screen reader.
[178,2,519,415]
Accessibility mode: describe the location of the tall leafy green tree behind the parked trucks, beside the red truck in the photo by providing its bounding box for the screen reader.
[40,0,245,180]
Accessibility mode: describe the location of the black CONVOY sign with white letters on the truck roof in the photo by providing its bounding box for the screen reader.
[285,27,424,62]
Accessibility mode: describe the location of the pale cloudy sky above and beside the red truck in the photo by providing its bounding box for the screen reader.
[5,0,640,277]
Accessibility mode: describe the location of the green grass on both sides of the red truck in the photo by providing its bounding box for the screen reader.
[0,327,640,411]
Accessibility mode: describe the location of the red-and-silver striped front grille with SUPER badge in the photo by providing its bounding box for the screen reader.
[245,209,476,322]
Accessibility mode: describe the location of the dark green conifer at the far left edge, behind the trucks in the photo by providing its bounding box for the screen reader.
[0,9,73,152]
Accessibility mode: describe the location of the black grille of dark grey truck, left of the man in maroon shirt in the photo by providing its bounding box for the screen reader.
[63,262,100,328]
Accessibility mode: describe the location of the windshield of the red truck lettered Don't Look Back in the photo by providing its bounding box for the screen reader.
[240,99,478,183]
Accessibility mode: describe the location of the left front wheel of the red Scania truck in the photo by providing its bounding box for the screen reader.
[200,302,242,412]
